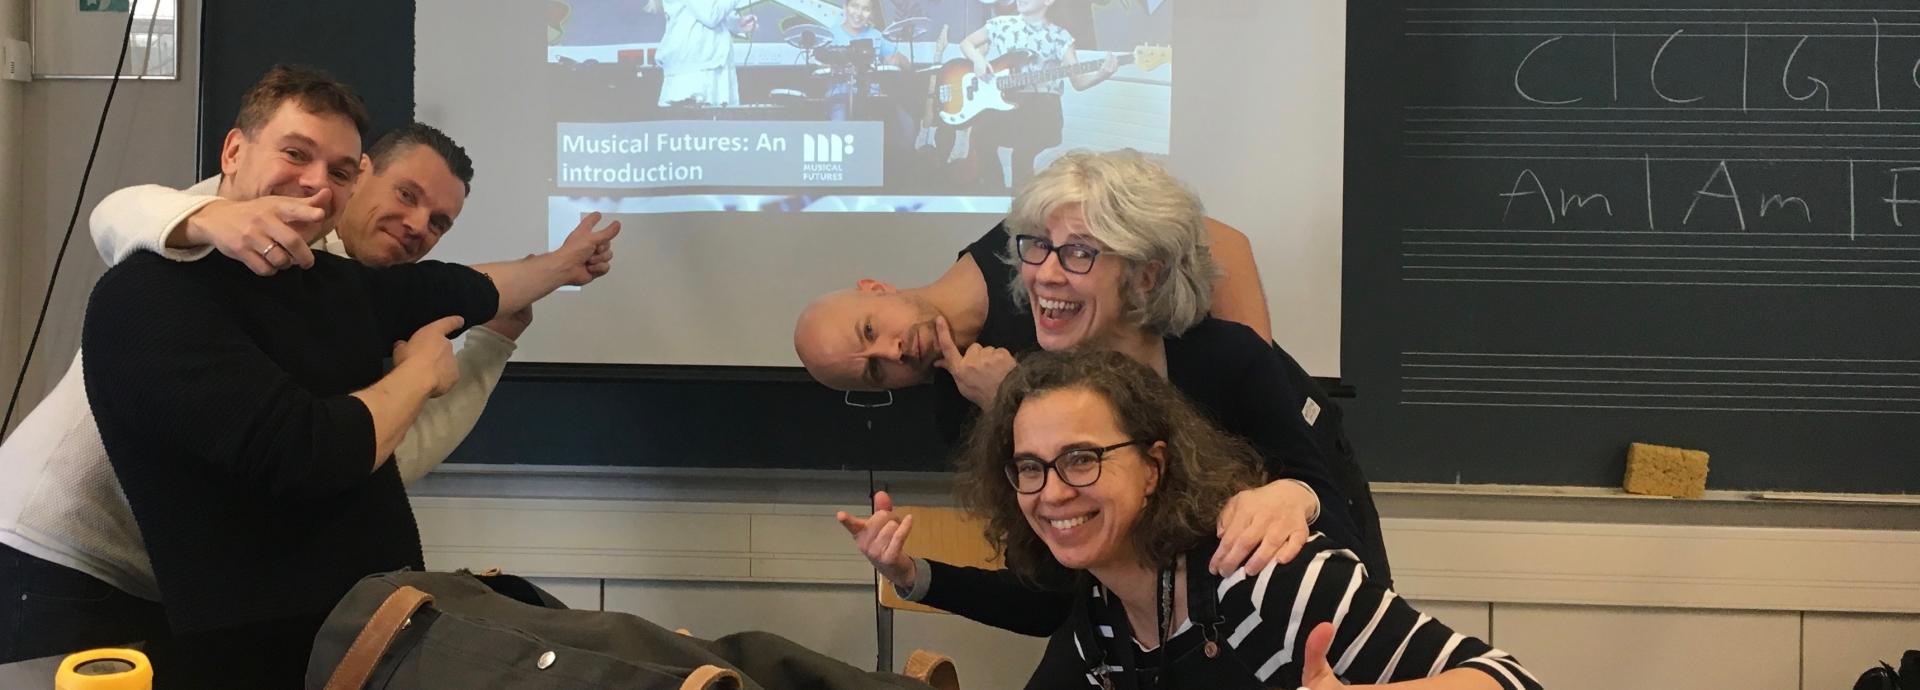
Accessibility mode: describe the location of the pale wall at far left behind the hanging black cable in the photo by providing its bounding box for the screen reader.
[0,0,200,430]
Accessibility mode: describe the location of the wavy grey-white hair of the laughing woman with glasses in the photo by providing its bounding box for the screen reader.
[1006,148,1221,336]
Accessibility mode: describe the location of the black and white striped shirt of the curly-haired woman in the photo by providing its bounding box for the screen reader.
[1027,534,1542,690]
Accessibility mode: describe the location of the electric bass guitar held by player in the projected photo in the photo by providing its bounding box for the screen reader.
[937,46,1173,127]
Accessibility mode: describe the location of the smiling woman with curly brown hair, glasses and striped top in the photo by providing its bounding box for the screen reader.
[958,352,1540,690]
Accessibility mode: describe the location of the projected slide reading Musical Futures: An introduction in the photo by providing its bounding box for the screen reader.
[541,0,1175,215]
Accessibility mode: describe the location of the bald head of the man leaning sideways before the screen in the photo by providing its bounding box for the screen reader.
[793,281,941,390]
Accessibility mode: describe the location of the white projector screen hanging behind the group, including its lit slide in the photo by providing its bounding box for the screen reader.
[415,0,1346,375]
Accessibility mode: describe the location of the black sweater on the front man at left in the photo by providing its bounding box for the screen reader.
[81,254,499,632]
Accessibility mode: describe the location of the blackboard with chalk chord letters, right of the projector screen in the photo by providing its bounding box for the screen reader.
[1342,0,1920,492]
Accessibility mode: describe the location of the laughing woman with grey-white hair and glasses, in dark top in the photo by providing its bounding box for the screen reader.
[841,152,1384,645]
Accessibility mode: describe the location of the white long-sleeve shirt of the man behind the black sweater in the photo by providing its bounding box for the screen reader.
[0,177,515,600]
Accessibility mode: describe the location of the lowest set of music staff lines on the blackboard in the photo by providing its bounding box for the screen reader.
[1400,352,1920,415]
